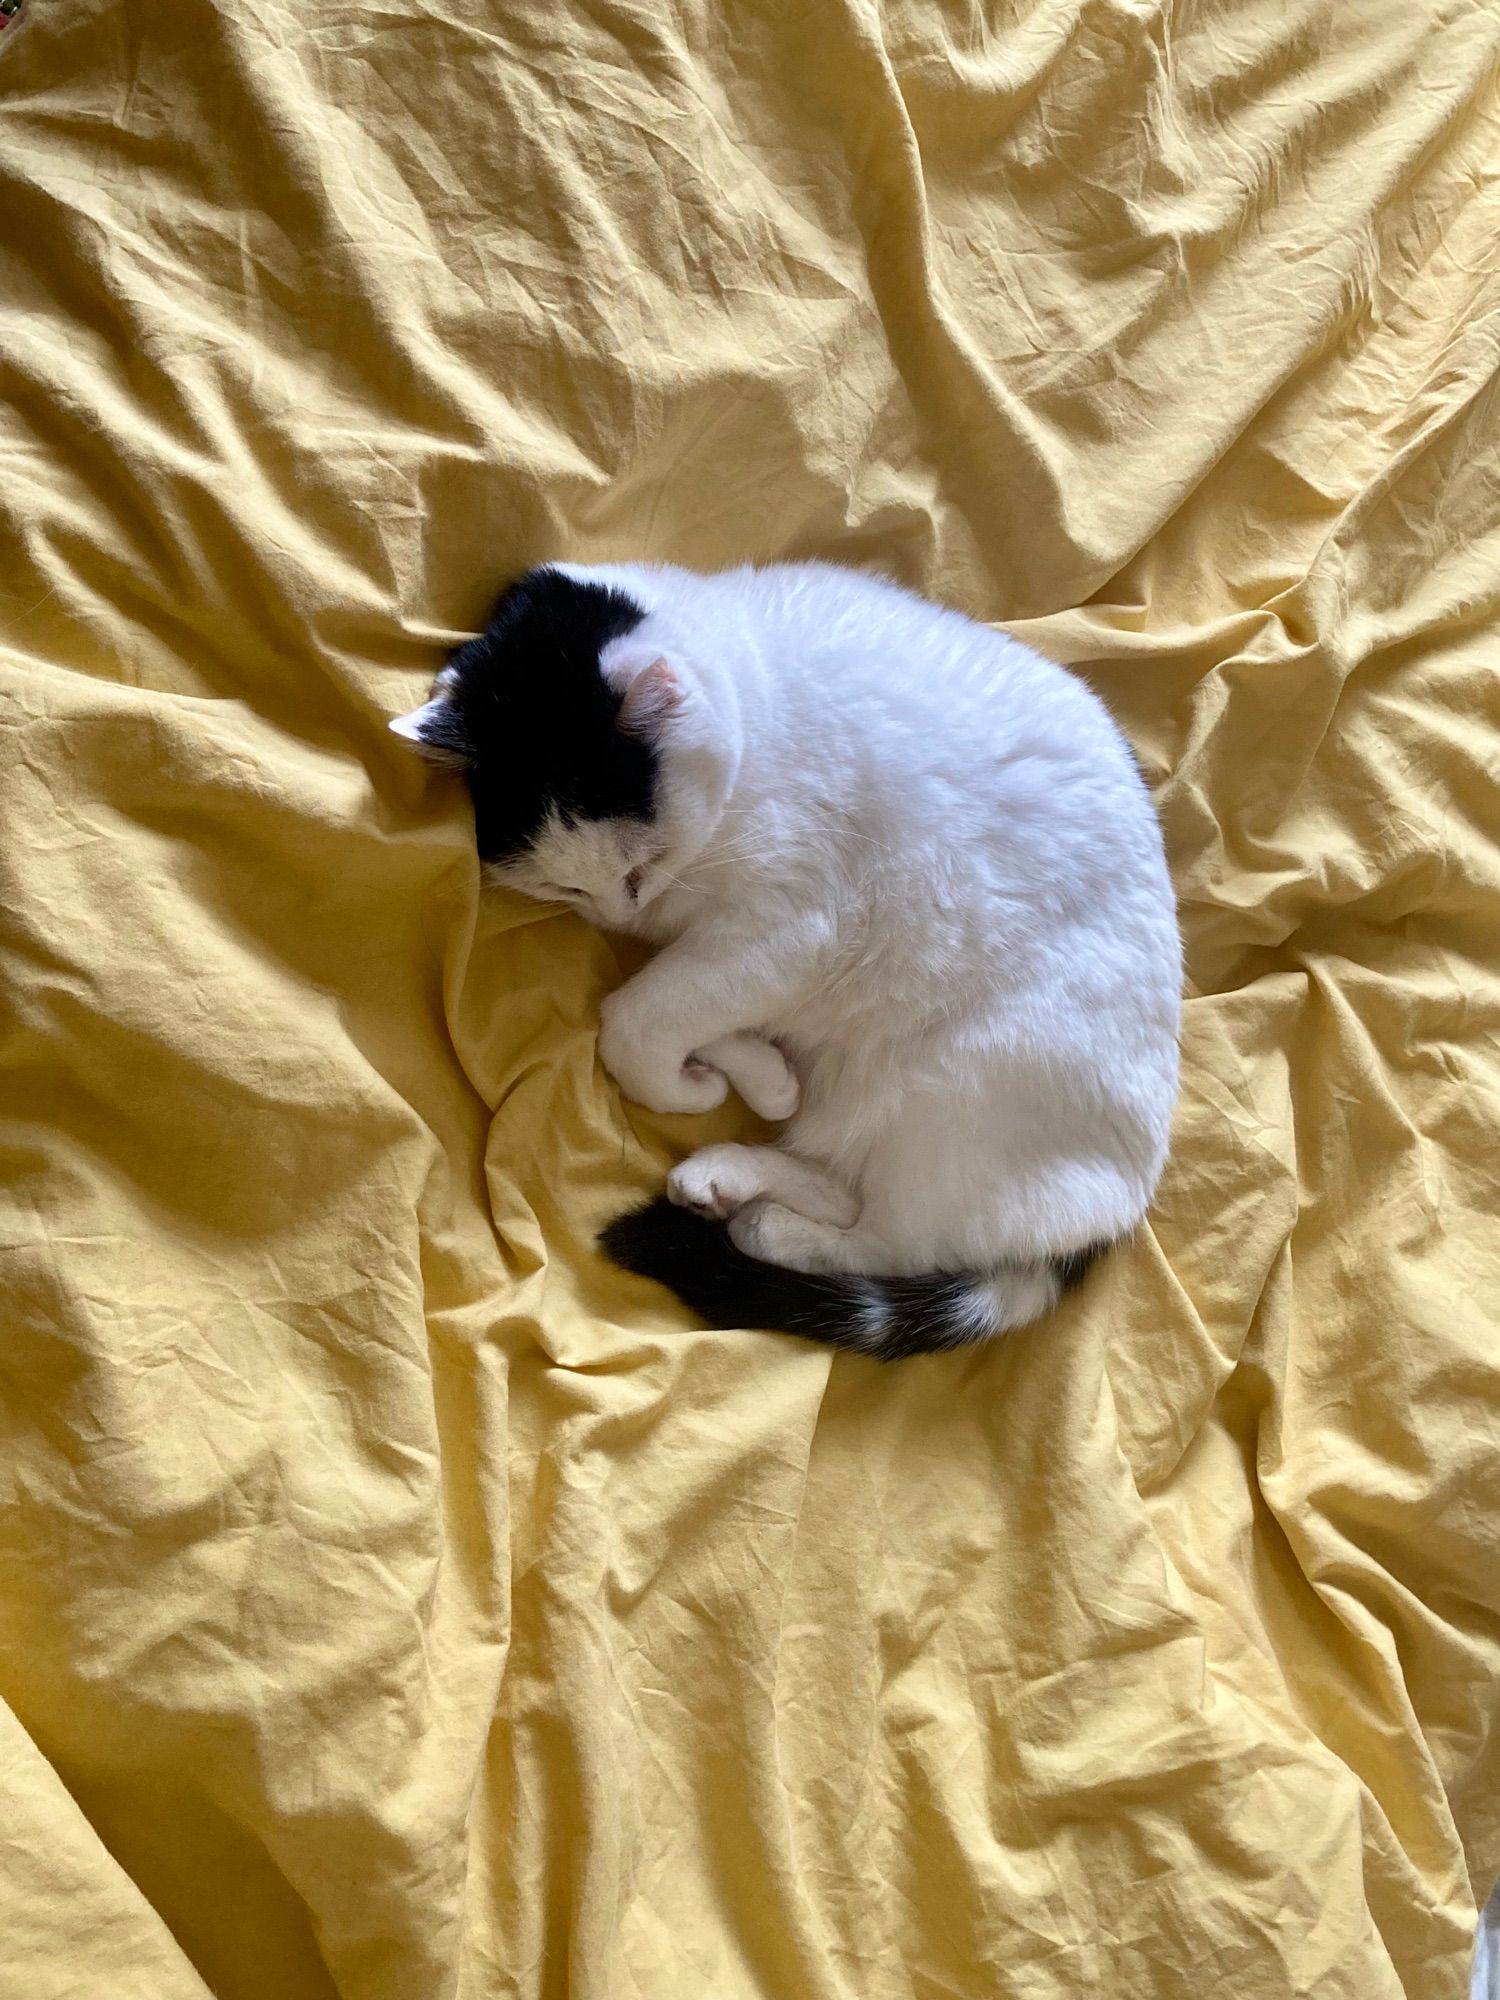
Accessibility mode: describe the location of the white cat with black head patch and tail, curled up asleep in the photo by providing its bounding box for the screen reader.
[392,562,1182,1360]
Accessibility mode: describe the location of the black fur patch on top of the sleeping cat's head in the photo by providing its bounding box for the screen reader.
[422,568,656,862]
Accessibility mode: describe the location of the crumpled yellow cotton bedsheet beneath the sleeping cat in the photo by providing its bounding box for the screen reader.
[0,0,1500,2000]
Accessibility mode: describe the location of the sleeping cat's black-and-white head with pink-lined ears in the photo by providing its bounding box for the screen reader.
[390,568,704,930]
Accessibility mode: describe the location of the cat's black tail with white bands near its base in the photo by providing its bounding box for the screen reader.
[600,1198,1104,1362]
